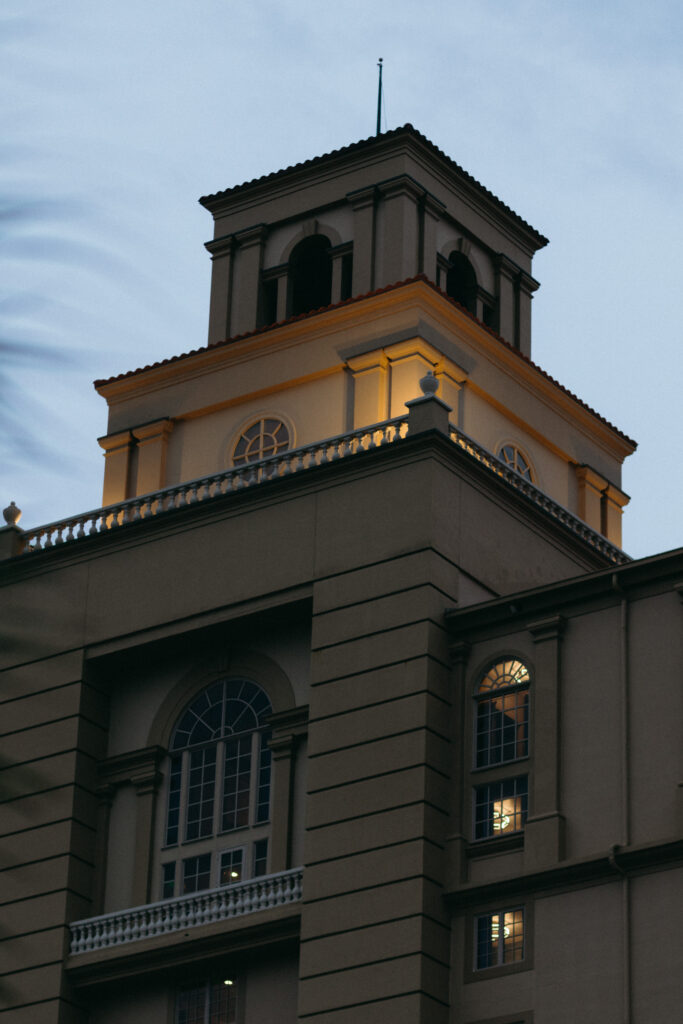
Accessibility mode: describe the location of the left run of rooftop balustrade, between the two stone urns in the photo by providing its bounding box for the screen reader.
[22,416,408,554]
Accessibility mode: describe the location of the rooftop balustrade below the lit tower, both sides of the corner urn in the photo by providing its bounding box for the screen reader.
[12,416,629,565]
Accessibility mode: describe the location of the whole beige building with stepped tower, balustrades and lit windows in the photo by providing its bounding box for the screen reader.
[0,125,683,1024]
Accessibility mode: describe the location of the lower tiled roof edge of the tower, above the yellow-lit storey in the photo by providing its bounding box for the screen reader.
[93,273,637,449]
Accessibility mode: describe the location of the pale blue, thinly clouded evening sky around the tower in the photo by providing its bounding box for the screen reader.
[0,0,683,557]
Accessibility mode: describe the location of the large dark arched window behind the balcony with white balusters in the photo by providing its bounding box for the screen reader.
[162,678,271,898]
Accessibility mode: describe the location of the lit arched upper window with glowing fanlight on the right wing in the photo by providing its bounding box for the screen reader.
[475,658,529,768]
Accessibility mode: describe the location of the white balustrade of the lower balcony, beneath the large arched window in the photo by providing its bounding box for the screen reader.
[69,867,303,954]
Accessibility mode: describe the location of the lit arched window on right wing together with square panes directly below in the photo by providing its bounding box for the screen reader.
[474,657,529,840]
